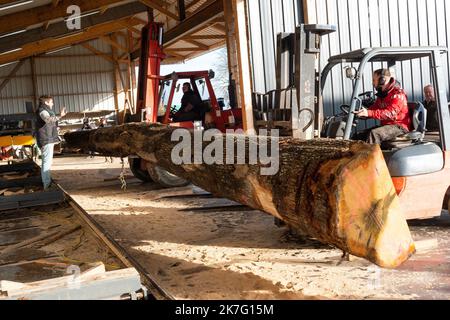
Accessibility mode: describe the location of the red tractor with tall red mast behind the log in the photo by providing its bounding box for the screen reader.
[129,23,242,187]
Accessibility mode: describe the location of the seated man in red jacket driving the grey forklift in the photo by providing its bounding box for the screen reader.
[355,69,412,144]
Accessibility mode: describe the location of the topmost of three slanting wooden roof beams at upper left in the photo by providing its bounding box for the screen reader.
[0,0,131,35]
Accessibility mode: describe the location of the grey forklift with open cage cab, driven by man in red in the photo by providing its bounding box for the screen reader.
[321,47,450,219]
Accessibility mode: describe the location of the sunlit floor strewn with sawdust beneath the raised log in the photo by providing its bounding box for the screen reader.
[53,157,450,299]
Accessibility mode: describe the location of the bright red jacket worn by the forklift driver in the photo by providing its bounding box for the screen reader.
[368,85,412,131]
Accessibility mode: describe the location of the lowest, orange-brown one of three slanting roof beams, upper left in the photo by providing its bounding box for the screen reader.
[0,18,141,65]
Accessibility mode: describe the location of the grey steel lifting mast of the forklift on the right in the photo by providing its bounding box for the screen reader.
[253,24,336,140]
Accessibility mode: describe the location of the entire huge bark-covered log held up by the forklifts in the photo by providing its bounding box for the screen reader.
[65,124,415,268]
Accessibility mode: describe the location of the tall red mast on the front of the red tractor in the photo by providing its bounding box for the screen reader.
[136,22,166,123]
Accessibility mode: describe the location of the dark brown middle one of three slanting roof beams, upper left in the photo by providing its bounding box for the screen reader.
[0,3,147,53]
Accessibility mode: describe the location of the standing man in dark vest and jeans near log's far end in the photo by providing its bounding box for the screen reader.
[36,96,66,189]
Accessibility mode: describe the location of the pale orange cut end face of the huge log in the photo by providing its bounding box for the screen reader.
[336,145,415,268]
